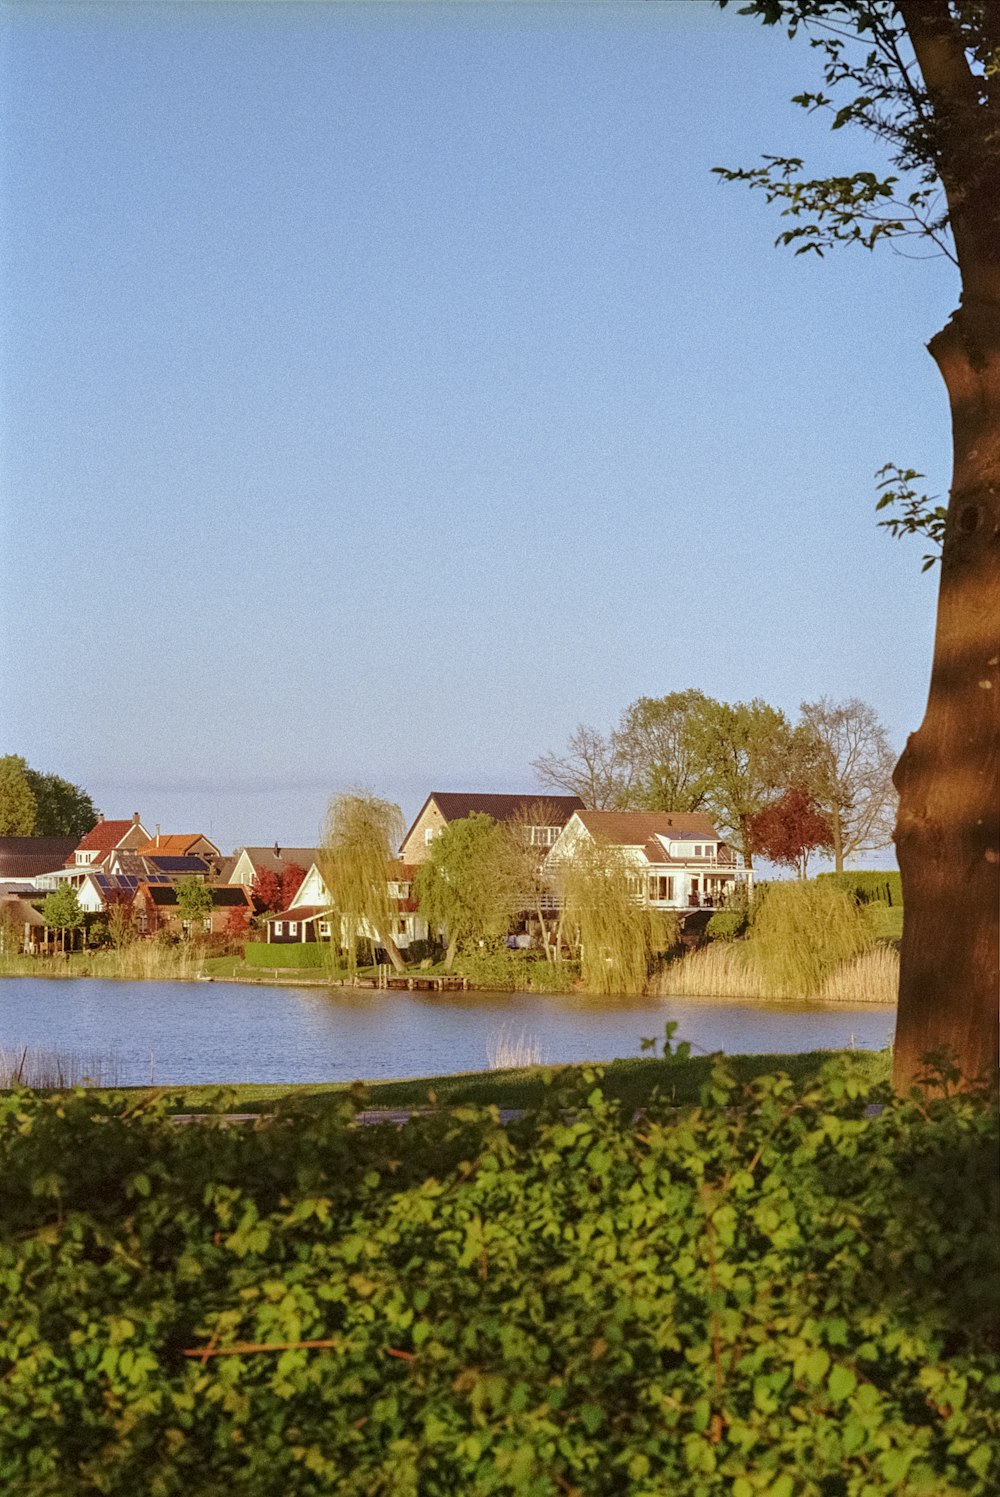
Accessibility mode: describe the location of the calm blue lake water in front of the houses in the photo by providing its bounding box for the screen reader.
[0,978,895,1085]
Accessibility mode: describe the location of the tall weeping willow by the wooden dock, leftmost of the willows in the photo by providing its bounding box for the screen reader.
[319,790,406,972]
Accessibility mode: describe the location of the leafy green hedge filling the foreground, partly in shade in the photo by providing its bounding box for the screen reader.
[0,1064,1000,1497]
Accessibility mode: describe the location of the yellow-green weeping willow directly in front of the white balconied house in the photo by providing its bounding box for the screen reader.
[558,838,677,994]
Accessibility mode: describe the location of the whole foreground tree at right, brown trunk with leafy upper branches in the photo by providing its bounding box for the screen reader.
[720,0,1000,1088]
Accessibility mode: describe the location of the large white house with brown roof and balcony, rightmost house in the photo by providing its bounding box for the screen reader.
[545,811,753,910]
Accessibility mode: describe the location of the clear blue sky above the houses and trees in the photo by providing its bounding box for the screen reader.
[0,0,957,847]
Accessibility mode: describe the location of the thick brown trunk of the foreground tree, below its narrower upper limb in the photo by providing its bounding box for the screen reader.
[892,295,1000,1091]
